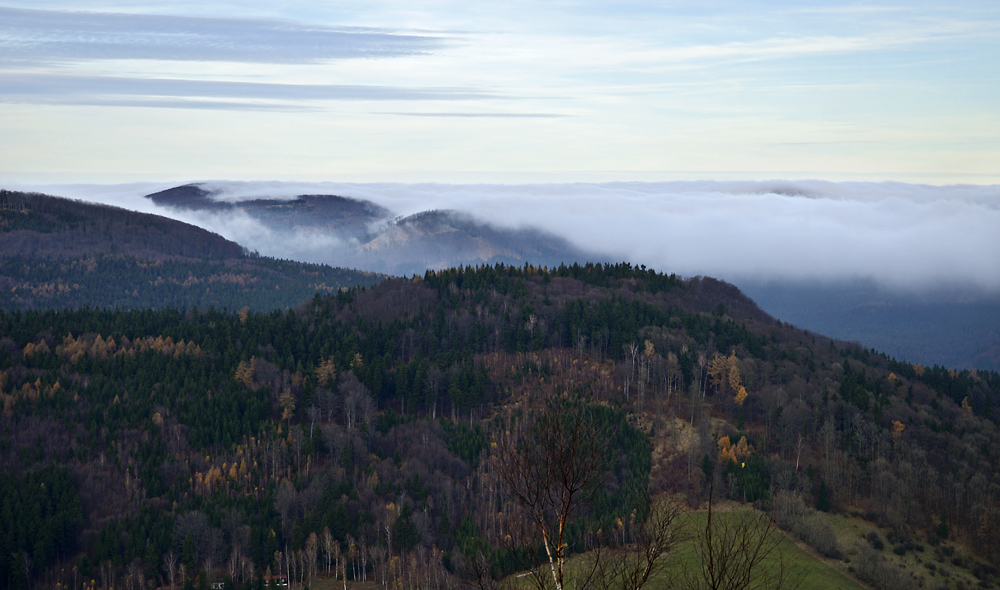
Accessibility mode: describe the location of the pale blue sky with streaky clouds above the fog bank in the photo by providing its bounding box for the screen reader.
[0,0,1000,184]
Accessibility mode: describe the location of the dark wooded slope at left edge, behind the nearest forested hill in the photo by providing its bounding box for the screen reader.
[0,191,381,309]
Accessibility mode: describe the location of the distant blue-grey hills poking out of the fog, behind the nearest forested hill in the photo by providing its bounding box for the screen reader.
[147,184,607,275]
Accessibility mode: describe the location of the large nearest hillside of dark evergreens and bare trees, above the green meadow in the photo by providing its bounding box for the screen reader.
[0,264,1000,588]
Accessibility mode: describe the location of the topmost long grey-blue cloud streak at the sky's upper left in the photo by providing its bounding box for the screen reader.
[0,7,447,63]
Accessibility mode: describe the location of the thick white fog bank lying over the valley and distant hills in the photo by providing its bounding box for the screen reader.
[15,181,1000,292]
